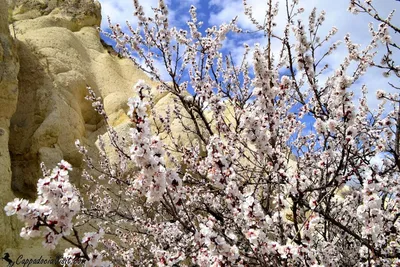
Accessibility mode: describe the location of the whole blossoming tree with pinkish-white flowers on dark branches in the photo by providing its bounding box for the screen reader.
[5,0,400,266]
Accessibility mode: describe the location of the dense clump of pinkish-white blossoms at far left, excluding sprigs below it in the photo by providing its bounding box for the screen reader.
[5,161,80,249]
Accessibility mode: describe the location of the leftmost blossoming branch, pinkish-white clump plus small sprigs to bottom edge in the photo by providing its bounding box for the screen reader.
[5,160,109,267]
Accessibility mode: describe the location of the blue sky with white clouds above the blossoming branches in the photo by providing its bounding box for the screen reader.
[99,0,400,111]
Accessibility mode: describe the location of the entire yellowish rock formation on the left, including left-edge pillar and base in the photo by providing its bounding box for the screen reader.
[0,0,163,258]
